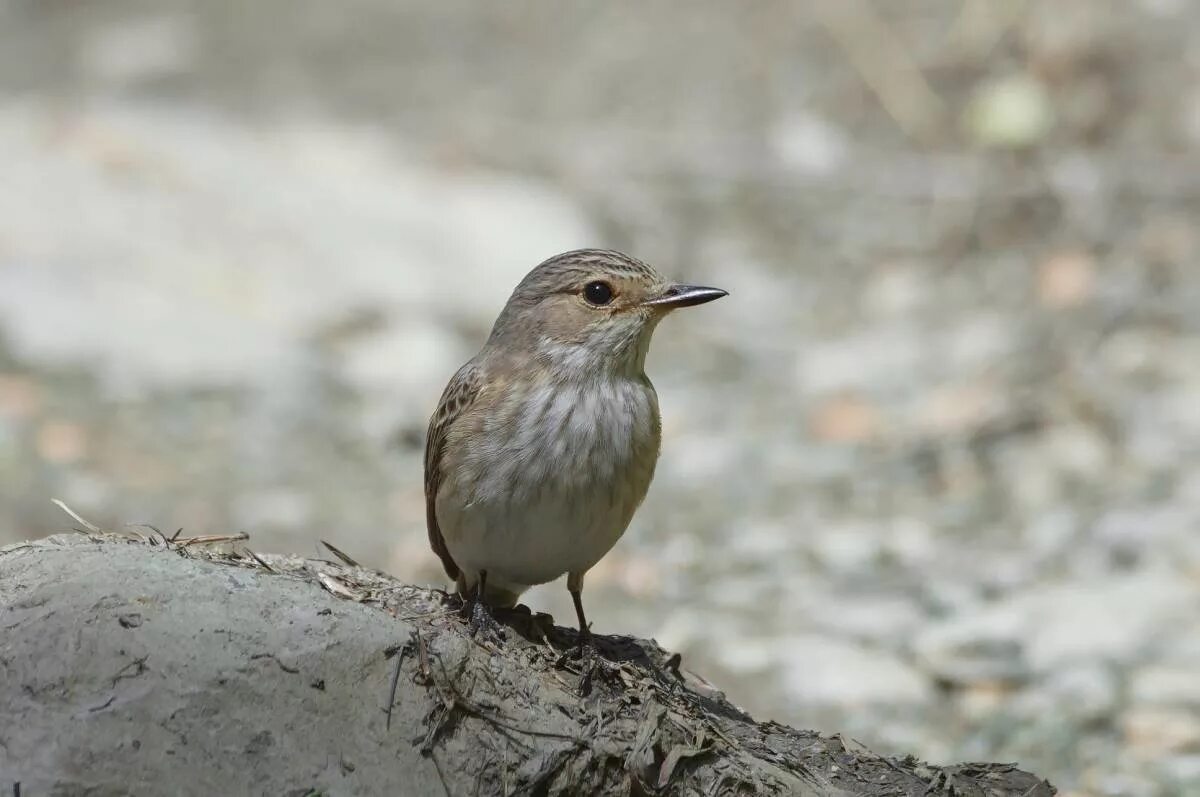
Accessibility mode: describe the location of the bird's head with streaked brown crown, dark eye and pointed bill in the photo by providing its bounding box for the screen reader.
[488,250,726,374]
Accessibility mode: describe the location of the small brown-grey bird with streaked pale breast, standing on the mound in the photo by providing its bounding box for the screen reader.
[425,248,727,647]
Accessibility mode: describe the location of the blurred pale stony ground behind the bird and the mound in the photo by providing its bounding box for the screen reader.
[0,0,1200,797]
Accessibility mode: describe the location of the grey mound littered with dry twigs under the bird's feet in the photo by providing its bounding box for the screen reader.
[0,533,1054,797]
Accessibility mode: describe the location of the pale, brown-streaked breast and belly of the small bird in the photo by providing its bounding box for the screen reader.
[437,378,659,594]
